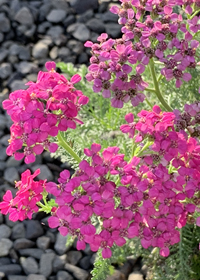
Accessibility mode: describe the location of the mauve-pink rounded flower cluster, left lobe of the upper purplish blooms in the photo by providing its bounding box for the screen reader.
[85,33,145,108]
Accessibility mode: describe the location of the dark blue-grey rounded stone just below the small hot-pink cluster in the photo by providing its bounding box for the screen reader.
[26,220,44,239]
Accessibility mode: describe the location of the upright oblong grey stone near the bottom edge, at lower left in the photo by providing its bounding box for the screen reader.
[40,253,55,277]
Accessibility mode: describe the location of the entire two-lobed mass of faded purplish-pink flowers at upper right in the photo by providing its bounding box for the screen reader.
[85,0,200,108]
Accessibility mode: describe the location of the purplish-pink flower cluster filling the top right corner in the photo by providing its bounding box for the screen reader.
[111,0,200,87]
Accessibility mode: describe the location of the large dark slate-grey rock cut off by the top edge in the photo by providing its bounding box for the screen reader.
[70,0,99,14]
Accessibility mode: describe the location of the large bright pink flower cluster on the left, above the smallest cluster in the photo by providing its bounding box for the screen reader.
[3,62,89,163]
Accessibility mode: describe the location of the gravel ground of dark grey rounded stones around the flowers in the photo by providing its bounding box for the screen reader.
[0,0,146,280]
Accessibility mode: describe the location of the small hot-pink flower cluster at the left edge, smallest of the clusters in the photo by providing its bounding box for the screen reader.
[0,169,46,222]
